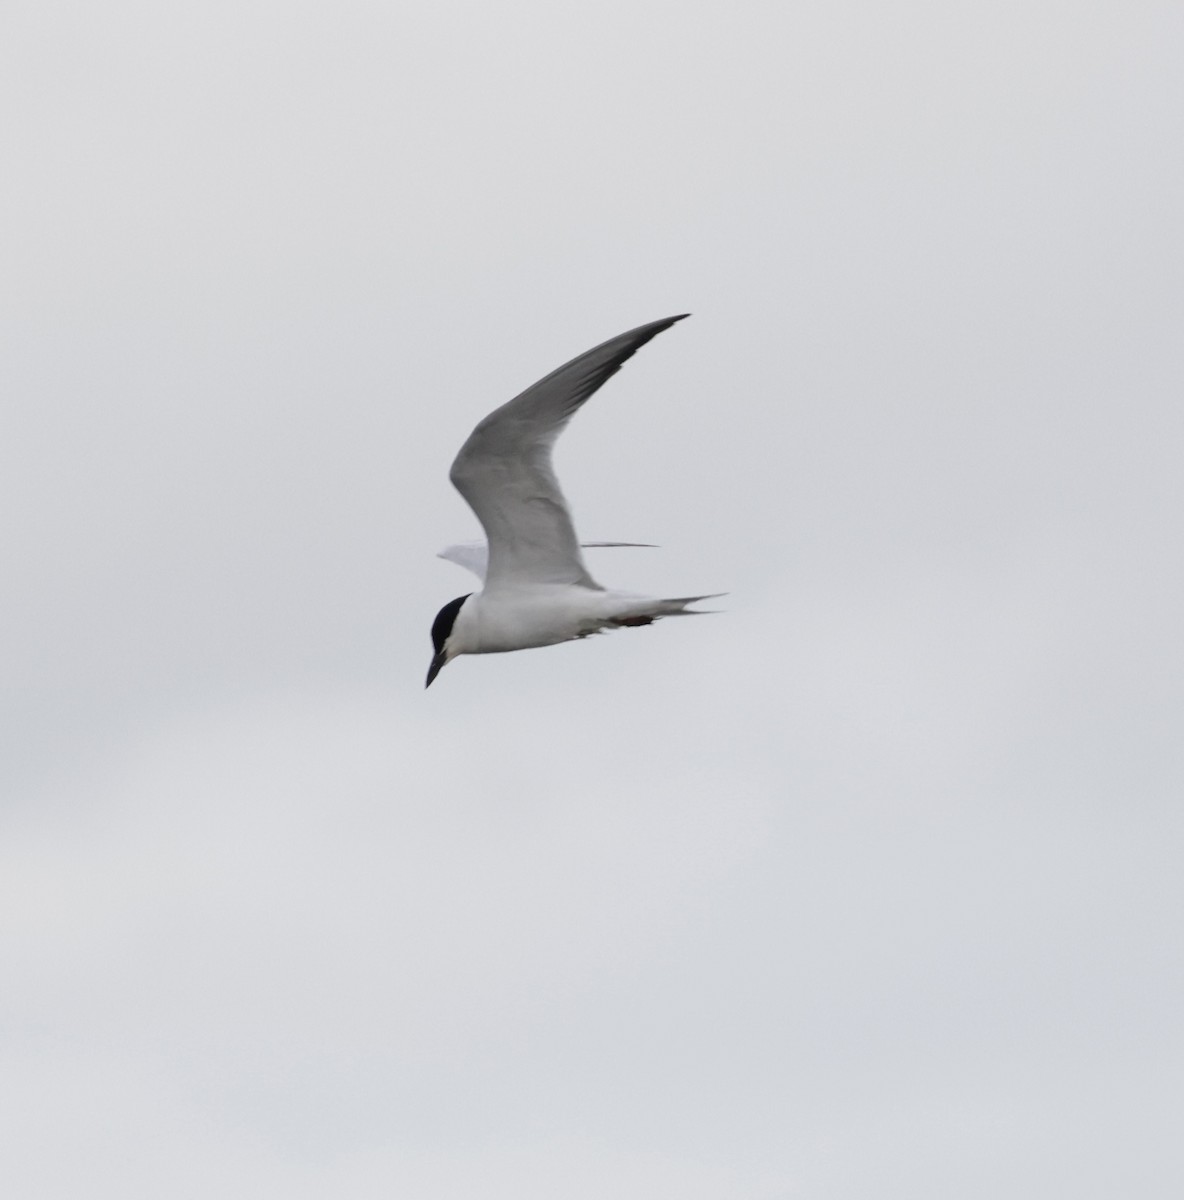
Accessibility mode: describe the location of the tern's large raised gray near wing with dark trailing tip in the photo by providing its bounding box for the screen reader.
[450,313,690,590]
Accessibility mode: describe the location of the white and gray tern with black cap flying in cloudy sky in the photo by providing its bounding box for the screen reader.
[425,313,722,688]
